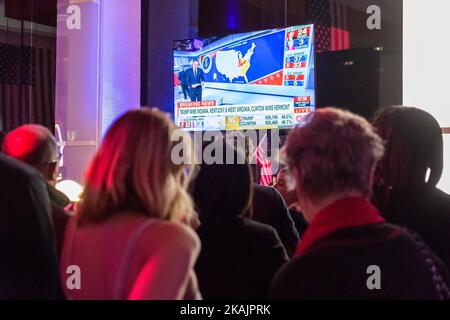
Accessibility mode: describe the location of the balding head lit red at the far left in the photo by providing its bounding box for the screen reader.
[3,124,57,184]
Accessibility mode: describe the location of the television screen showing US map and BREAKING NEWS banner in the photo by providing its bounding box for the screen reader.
[173,25,315,131]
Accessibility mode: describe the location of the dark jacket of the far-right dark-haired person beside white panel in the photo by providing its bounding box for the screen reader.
[379,187,450,270]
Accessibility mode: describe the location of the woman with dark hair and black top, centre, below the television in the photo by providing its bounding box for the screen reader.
[192,144,287,299]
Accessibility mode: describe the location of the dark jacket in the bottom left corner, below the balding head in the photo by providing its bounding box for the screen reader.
[0,154,60,299]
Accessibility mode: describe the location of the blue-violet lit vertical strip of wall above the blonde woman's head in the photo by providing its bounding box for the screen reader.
[99,0,141,136]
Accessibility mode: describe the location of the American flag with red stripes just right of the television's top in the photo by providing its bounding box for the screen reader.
[306,0,350,52]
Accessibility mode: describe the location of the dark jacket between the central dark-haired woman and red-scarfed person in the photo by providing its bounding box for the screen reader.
[252,184,299,256]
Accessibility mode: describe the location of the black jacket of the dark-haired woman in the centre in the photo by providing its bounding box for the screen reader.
[195,218,288,300]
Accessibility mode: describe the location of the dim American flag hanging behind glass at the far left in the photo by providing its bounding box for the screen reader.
[0,44,56,132]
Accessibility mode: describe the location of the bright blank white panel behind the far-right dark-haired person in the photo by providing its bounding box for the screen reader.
[403,0,450,193]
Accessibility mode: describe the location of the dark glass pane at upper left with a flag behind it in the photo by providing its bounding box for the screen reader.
[0,0,56,132]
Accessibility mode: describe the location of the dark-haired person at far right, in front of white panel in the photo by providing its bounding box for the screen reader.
[373,107,450,268]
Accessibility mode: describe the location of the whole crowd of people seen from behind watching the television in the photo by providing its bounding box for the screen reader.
[0,107,450,300]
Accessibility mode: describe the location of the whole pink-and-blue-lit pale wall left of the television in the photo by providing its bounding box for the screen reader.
[55,0,141,183]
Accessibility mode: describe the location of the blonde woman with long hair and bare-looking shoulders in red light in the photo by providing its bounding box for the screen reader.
[60,109,200,300]
